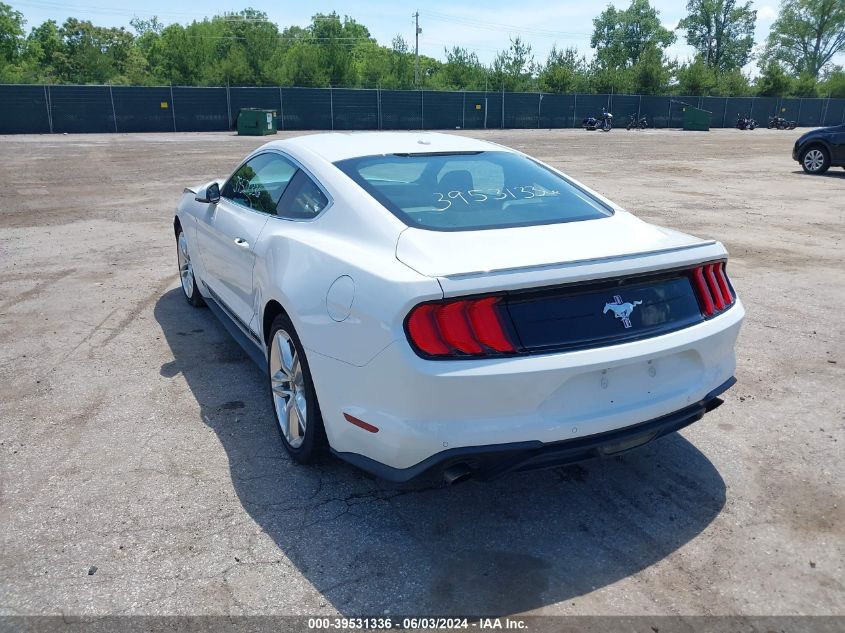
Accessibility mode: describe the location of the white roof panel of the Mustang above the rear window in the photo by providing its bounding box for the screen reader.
[265,131,507,163]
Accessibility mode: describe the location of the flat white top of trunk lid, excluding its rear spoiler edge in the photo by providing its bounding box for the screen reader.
[396,211,713,277]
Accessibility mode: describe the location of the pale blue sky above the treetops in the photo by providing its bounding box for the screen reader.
[4,0,845,74]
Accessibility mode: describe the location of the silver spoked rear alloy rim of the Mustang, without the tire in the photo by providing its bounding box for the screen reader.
[270,329,308,449]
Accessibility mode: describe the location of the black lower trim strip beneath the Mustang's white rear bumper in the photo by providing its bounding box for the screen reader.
[333,377,736,483]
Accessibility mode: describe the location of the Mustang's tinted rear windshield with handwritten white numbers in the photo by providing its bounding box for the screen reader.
[335,152,613,231]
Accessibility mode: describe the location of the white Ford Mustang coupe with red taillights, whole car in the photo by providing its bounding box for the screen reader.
[174,132,745,482]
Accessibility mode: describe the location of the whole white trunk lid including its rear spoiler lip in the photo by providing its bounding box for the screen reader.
[396,211,727,298]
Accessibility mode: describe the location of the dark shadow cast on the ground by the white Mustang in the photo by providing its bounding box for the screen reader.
[155,288,725,616]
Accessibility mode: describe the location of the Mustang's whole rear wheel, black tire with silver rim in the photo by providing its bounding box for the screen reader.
[267,314,327,464]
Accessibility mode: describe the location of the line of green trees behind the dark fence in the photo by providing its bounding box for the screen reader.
[0,0,845,96]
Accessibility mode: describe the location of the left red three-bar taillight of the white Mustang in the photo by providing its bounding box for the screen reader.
[407,297,516,357]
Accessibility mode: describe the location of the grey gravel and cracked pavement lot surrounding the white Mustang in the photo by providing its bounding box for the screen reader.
[0,130,845,615]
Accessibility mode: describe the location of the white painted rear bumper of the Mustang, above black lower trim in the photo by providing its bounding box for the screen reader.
[308,301,744,479]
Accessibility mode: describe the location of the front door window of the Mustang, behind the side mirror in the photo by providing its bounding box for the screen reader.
[220,154,297,213]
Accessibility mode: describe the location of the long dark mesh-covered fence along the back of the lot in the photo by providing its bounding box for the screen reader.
[0,84,845,134]
